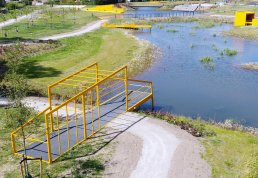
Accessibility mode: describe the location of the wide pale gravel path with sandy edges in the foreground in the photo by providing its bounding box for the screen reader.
[104,113,211,178]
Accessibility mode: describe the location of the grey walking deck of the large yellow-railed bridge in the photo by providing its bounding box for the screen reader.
[18,91,149,161]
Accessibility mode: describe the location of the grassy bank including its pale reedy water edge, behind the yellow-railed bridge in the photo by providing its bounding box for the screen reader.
[0,28,154,96]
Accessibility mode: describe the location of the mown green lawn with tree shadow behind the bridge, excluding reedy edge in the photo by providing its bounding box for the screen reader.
[17,28,141,95]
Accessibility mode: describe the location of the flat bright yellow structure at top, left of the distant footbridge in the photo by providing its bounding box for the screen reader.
[85,4,125,14]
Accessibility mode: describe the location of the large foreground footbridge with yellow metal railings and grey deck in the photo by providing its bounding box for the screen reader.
[11,63,154,164]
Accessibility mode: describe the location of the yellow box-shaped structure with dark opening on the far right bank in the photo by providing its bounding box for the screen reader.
[234,11,258,26]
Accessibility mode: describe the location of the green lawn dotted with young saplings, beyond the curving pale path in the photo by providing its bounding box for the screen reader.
[0,8,97,41]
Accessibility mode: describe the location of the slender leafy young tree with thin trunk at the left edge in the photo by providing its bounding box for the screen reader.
[1,43,31,177]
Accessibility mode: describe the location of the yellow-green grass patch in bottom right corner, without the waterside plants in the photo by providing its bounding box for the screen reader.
[202,125,258,178]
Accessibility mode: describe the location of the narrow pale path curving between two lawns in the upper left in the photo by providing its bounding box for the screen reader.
[40,20,106,40]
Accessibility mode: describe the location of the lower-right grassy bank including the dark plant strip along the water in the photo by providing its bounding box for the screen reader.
[142,112,258,178]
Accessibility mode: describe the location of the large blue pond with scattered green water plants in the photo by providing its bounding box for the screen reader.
[136,22,258,127]
